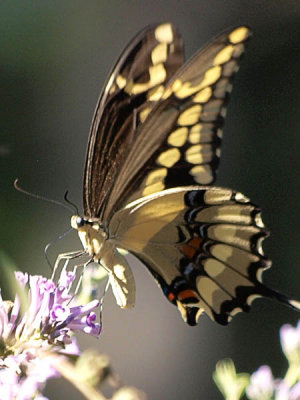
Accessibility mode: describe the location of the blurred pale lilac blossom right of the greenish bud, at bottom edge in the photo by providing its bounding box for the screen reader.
[246,365,275,400]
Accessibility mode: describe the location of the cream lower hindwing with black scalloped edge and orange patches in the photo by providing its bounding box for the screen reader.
[109,186,271,325]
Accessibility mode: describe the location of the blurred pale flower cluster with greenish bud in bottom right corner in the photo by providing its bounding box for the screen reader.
[213,321,300,400]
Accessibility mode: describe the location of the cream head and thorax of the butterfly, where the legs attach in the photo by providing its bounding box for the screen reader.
[71,215,107,260]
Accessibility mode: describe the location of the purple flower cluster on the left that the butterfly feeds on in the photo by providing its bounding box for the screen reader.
[0,270,101,400]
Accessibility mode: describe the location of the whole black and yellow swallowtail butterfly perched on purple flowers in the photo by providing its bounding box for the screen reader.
[64,23,299,325]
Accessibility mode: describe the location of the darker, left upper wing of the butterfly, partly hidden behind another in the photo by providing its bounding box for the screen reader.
[83,23,184,217]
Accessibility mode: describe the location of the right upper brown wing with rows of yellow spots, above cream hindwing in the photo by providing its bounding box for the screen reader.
[105,26,250,220]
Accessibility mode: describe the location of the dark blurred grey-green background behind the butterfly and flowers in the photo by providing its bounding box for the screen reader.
[0,0,300,400]
